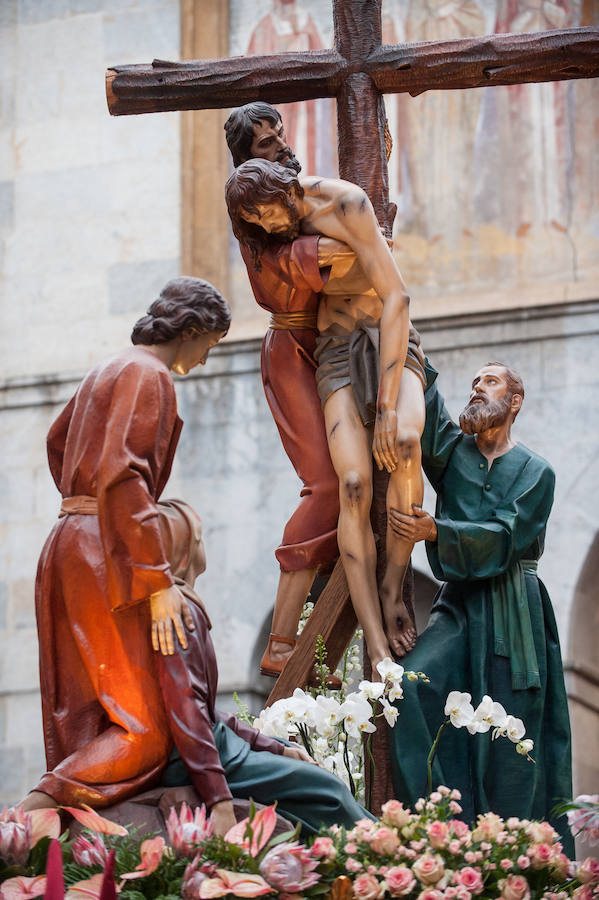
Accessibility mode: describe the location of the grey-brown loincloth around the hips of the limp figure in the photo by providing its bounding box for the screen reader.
[314,323,426,426]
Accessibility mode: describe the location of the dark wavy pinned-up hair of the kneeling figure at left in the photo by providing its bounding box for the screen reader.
[131,276,231,345]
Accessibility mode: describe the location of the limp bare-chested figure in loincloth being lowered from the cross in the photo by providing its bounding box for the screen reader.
[226,159,424,669]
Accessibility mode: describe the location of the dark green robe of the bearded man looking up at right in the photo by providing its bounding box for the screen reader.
[390,367,573,853]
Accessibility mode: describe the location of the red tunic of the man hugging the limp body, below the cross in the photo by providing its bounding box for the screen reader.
[241,235,339,572]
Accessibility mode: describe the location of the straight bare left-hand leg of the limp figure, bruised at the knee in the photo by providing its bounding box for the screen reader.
[324,386,391,677]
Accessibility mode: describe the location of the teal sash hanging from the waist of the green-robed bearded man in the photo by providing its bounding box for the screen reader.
[491,559,541,691]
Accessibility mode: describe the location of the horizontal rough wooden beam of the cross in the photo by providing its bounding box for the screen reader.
[106,28,599,116]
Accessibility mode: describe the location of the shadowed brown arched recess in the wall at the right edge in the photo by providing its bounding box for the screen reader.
[564,532,599,796]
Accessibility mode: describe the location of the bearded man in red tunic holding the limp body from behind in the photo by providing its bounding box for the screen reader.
[225,102,341,676]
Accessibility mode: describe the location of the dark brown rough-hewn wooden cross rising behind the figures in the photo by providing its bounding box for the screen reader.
[106,0,599,799]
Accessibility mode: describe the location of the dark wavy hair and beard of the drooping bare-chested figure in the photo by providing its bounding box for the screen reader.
[225,159,304,271]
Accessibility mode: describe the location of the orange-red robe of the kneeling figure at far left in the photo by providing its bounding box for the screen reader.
[36,347,182,807]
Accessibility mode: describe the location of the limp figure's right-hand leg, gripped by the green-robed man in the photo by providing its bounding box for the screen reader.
[381,369,425,657]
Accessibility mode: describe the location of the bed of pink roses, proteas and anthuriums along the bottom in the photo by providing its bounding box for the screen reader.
[0,785,599,900]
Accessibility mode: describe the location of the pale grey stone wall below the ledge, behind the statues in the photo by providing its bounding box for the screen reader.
[0,302,599,802]
